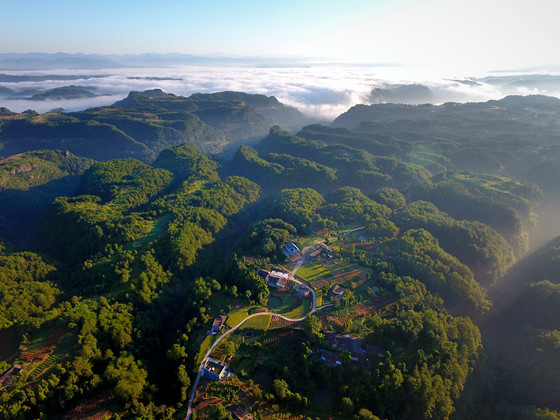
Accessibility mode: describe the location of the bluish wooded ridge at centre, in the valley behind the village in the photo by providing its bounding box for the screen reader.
[230,127,430,193]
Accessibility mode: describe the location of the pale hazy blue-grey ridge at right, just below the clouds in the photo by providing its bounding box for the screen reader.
[330,95,560,200]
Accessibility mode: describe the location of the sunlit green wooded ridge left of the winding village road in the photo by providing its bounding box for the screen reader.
[0,146,268,418]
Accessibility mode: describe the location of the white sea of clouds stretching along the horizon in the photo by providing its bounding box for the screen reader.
[0,65,560,120]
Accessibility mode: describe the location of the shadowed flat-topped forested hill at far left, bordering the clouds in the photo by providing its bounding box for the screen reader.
[0,89,309,162]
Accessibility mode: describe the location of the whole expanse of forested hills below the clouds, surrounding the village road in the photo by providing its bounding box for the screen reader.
[0,90,560,419]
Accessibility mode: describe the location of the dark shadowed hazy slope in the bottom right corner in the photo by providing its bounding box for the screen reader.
[461,237,560,419]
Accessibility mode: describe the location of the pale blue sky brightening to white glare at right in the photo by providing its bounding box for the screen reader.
[0,0,560,68]
